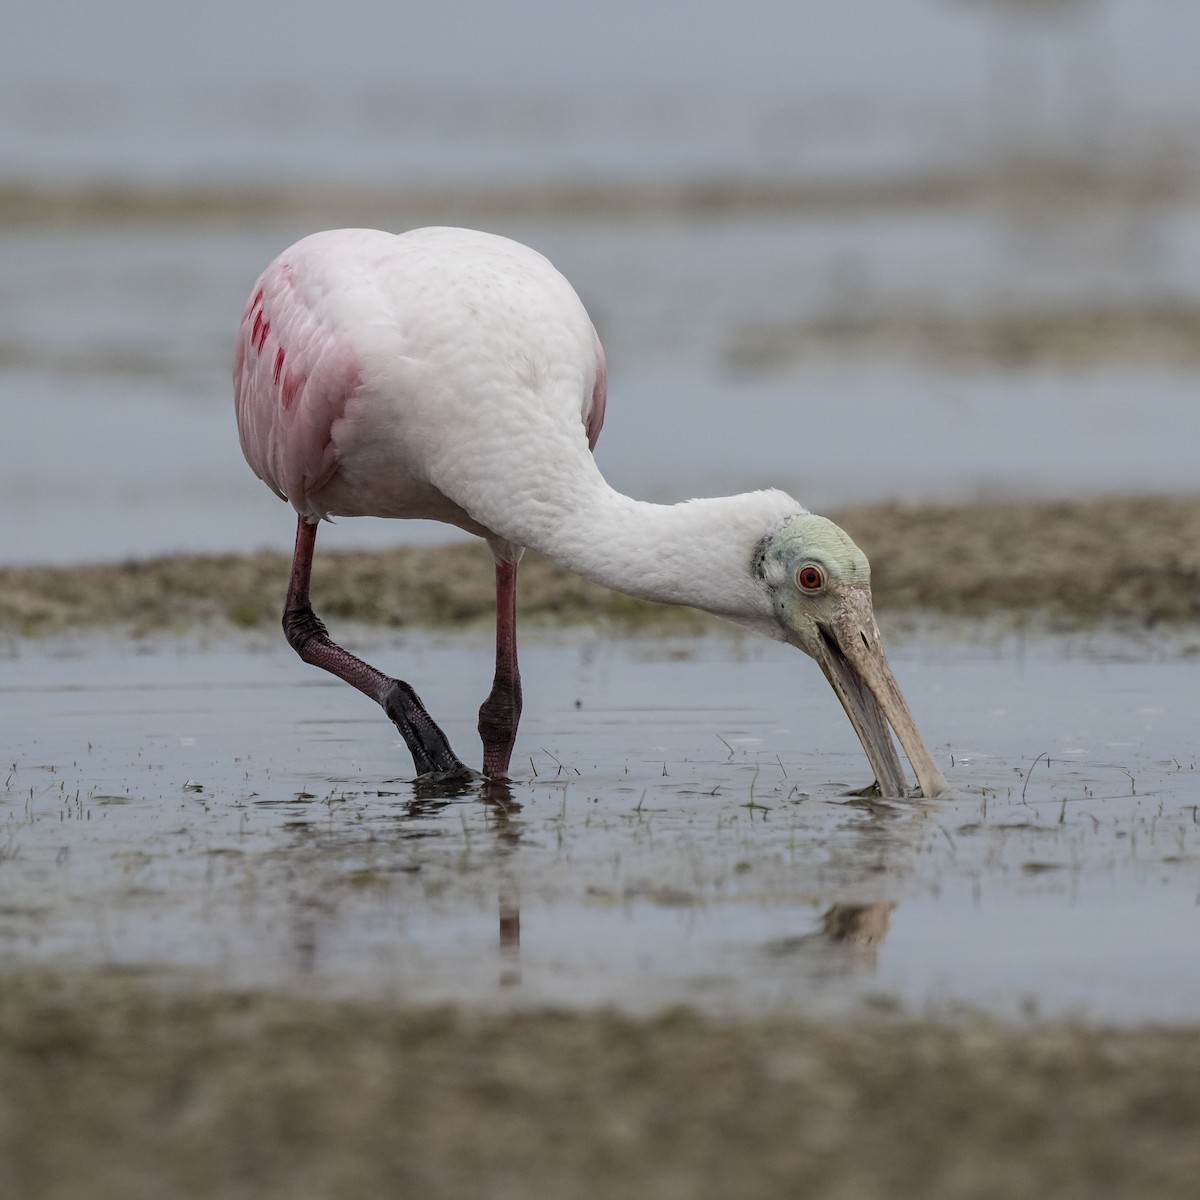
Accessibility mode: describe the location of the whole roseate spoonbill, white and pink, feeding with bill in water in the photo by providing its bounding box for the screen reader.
[233,228,947,796]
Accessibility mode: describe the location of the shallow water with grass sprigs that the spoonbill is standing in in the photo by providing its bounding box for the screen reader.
[0,634,1200,1022]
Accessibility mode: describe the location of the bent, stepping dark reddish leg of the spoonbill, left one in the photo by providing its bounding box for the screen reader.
[283,517,468,775]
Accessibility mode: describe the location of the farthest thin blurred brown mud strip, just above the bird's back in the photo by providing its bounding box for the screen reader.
[0,154,1200,228]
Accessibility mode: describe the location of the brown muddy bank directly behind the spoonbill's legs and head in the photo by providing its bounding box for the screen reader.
[0,496,1200,637]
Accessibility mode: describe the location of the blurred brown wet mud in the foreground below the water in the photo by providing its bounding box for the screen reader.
[9,974,1200,1200]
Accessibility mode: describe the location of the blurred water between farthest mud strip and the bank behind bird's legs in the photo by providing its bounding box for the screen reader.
[7,210,1200,562]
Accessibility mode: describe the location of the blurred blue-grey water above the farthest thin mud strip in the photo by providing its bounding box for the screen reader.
[9,0,1200,184]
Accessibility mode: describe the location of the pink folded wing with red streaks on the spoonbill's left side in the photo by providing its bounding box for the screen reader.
[233,247,360,520]
